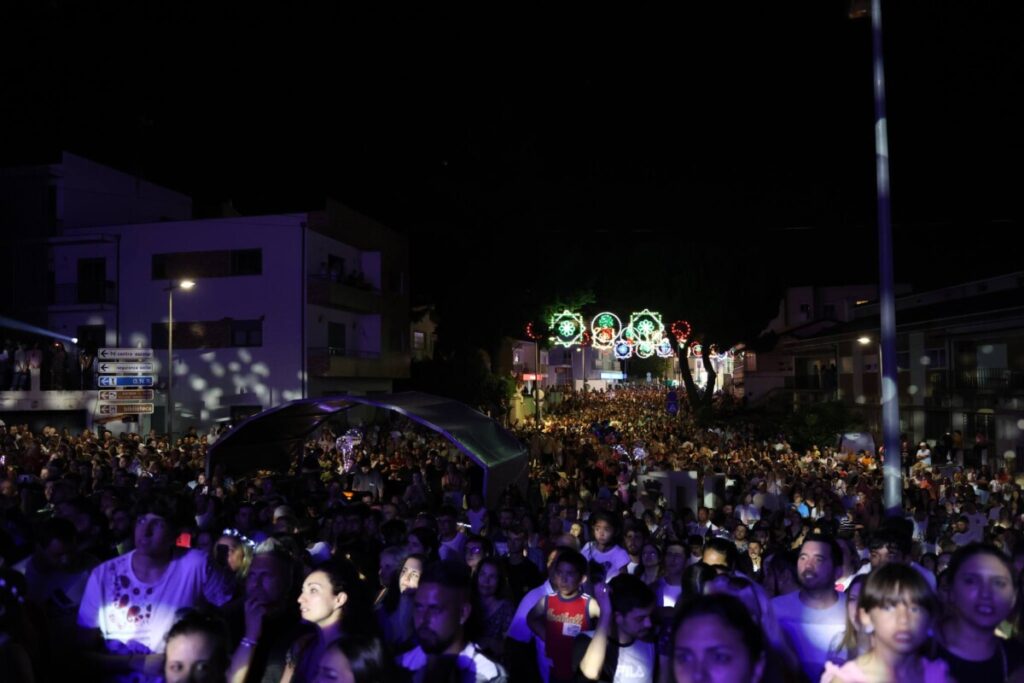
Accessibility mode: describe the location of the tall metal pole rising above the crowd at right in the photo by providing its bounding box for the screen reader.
[871,0,903,517]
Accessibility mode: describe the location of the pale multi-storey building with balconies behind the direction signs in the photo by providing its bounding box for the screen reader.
[0,153,410,432]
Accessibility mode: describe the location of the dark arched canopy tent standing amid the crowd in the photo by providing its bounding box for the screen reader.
[206,391,527,506]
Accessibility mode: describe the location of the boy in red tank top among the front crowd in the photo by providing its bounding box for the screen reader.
[526,549,600,683]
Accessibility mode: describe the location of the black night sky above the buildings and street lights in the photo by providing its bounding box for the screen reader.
[0,0,1024,348]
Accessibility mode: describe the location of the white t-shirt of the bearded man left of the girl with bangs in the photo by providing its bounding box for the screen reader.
[771,591,846,681]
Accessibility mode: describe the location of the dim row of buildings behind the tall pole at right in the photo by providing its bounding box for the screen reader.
[743,272,1024,464]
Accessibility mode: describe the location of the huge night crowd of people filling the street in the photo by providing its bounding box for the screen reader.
[0,386,1024,683]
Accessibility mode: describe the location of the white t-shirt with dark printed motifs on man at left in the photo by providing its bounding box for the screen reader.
[78,550,233,681]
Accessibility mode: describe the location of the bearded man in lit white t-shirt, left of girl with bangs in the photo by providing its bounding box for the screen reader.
[772,536,846,681]
